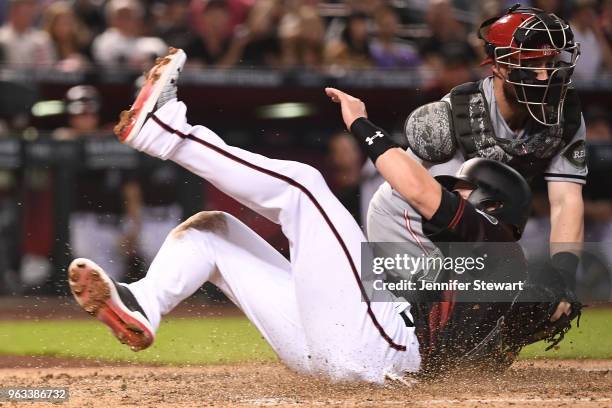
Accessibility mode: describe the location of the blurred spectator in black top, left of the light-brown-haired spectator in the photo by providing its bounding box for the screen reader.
[242,0,283,67]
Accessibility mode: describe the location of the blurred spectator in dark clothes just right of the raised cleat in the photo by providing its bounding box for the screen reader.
[185,0,247,68]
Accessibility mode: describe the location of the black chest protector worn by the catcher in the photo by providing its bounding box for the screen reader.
[450,81,581,179]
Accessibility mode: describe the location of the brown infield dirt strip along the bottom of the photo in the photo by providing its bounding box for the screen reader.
[0,357,612,407]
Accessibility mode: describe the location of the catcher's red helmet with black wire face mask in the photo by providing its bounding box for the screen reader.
[481,8,580,126]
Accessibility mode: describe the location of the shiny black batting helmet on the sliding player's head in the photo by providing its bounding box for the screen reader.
[436,157,531,240]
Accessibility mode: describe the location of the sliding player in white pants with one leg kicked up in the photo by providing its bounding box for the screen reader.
[68,50,580,383]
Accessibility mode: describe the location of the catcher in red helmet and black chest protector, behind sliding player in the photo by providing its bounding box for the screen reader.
[367,5,587,328]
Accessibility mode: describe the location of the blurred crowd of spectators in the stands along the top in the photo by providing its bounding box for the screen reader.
[0,0,612,83]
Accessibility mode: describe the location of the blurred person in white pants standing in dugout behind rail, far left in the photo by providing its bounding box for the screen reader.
[54,85,142,280]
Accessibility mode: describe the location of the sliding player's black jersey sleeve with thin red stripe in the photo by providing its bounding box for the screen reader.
[423,188,516,242]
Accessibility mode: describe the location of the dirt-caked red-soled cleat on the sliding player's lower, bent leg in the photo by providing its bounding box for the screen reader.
[68,258,155,351]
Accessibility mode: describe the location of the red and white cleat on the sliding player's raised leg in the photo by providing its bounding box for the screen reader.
[114,48,187,143]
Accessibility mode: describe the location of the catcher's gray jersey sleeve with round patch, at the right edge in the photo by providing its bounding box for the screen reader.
[544,118,588,184]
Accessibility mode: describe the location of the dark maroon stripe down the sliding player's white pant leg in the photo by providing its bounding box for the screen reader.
[151,114,406,351]
